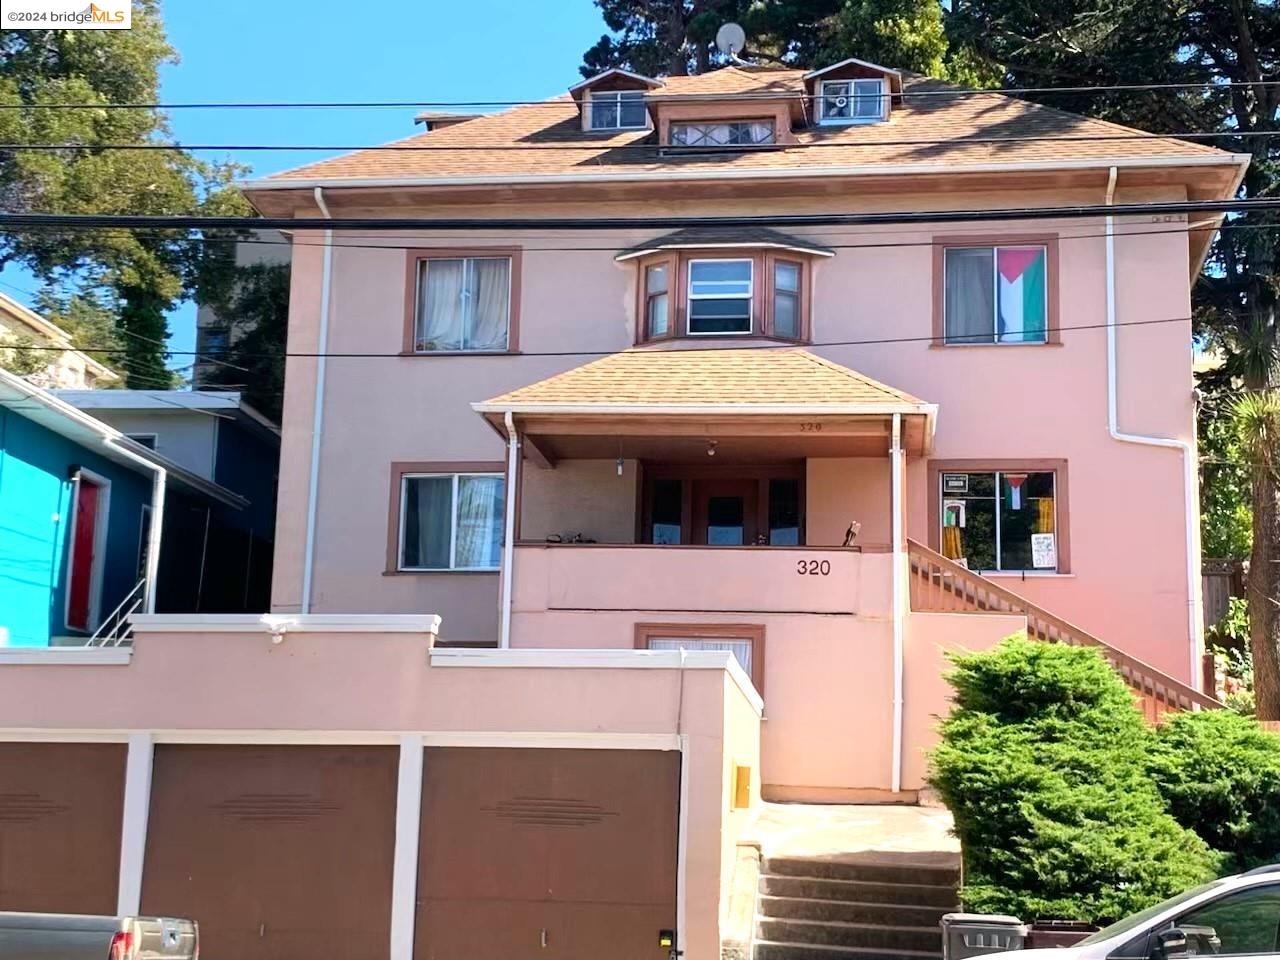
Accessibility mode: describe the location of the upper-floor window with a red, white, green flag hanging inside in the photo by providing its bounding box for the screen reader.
[942,244,1050,343]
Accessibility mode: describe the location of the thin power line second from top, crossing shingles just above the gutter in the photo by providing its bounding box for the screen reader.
[0,131,1280,159]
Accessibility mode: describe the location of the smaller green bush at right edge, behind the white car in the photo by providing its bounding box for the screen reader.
[1148,710,1280,870]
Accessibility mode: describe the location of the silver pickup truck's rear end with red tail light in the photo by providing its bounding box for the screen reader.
[0,913,200,960]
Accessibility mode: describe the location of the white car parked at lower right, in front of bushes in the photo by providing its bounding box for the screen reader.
[983,864,1280,960]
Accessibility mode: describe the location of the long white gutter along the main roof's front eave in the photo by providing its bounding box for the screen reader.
[237,150,1251,192]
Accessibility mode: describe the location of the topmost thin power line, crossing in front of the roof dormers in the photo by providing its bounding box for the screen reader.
[0,78,1280,110]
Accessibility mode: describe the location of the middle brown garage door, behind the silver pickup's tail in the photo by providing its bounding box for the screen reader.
[142,745,398,960]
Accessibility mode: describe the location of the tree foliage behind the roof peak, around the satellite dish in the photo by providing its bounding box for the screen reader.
[581,0,991,83]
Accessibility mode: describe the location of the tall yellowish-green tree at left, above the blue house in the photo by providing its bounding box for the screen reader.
[0,0,248,387]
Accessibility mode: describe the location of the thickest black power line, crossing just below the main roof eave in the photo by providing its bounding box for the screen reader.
[0,195,1280,232]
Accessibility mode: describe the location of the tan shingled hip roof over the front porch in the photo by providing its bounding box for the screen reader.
[471,347,937,417]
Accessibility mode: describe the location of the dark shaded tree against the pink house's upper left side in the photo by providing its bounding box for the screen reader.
[198,264,289,422]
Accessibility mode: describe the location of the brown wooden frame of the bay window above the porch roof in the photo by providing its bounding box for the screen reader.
[635,247,813,344]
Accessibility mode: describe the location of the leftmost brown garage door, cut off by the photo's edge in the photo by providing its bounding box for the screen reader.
[0,744,127,914]
